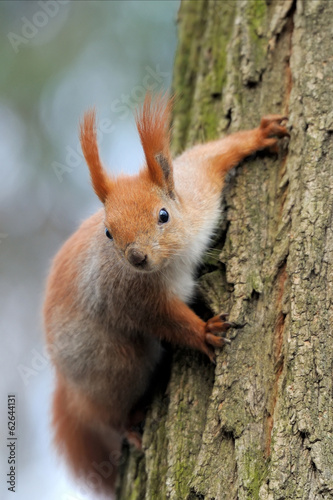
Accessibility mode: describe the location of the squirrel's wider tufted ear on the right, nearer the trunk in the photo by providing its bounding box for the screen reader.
[136,92,174,197]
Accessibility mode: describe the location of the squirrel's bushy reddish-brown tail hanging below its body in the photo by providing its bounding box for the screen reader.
[52,377,122,498]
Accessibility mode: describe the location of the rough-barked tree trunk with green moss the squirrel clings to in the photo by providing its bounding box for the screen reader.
[118,0,333,500]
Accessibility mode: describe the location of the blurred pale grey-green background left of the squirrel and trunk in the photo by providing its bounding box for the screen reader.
[0,0,179,500]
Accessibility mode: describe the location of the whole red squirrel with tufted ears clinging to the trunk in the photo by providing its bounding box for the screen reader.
[44,94,289,495]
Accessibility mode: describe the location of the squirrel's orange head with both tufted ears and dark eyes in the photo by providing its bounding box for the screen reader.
[81,94,184,272]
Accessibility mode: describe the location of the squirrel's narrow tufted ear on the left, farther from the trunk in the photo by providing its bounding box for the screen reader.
[80,109,113,203]
